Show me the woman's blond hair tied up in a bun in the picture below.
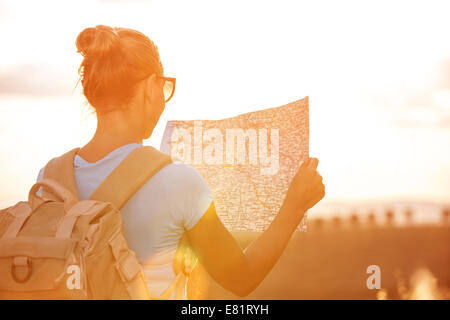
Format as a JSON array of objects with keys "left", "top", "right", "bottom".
[{"left": 76, "top": 25, "right": 164, "bottom": 114}]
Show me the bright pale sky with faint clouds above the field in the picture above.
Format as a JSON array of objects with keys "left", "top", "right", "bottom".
[{"left": 0, "top": 0, "right": 450, "bottom": 207}]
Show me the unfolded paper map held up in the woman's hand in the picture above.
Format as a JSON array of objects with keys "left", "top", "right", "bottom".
[{"left": 161, "top": 97, "right": 309, "bottom": 231}]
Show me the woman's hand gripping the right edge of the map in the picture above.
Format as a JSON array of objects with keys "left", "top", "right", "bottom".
[{"left": 283, "top": 158, "right": 325, "bottom": 222}]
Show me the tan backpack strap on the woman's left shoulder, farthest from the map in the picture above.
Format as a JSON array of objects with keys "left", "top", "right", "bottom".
[{"left": 42, "top": 148, "right": 80, "bottom": 201}]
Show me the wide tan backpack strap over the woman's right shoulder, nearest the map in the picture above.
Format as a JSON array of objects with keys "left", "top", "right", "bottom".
[{"left": 89, "top": 146, "right": 172, "bottom": 210}]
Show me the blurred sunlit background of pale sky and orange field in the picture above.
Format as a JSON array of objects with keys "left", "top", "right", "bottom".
[{"left": 0, "top": 0, "right": 450, "bottom": 299}]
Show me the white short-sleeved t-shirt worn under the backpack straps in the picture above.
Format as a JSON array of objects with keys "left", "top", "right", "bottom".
[{"left": 37, "top": 143, "right": 213, "bottom": 299}]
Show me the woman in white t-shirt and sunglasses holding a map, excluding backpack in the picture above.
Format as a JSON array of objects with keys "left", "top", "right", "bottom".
[{"left": 38, "top": 25, "right": 325, "bottom": 298}]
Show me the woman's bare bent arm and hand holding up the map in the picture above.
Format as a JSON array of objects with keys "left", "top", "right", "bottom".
[{"left": 187, "top": 158, "right": 325, "bottom": 296}]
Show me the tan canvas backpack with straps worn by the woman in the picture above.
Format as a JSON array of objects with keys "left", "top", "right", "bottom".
[{"left": 0, "top": 146, "right": 207, "bottom": 299}]
